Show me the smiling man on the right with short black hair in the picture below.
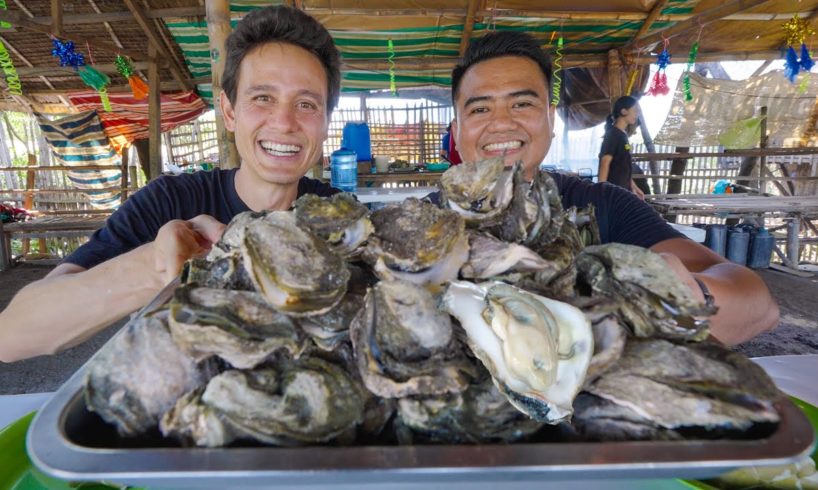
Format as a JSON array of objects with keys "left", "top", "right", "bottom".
[{"left": 452, "top": 31, "right": 778, "bottom": 344}]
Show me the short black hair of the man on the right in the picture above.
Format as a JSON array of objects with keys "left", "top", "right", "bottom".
[{"left": 452, "top": 31, "right": 553, "bottom": 106}]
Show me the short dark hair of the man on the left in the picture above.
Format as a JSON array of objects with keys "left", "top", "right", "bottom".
[{"left": 222, "top": 5, "right": 341, "bottom": 113}]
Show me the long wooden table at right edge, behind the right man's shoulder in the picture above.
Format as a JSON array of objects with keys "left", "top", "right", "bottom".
[{"left": 645, "top": 194, "right": 818, "bottom": 268}]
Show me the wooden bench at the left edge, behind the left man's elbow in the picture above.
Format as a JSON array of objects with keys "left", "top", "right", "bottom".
[{"left": 0, "top": 214, "right": 108, "bottom": 270}]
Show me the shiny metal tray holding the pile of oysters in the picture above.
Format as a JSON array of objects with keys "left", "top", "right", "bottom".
[{"left": 27, "top": 283, "right": 815, "bottom": 489}]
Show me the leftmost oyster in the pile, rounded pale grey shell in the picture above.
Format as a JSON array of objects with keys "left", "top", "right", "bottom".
[{"left": 84, "top": 311, "right": 210, "bottom": 436}]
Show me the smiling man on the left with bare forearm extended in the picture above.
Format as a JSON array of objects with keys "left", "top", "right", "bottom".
[{"left": 0, "top": 6, "right": 341, "bottom": 362}]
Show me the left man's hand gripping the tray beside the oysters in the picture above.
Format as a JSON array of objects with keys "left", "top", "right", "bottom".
[{"left": 153, "top": 214, "right": 225, "bottom": 282}]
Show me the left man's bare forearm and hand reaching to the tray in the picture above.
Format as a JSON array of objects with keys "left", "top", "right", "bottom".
[{"left": 0, "top": 216, "right": 224, "bottom": 362}]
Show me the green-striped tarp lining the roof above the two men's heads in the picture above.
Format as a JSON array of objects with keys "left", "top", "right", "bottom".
[{"left": 164, "top": 0, "right": 699, "bottom": 105}]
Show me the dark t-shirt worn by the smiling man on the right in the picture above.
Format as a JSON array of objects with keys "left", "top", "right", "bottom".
[{"left": 425, "top": 172, "right": 684, "bottom": 248}]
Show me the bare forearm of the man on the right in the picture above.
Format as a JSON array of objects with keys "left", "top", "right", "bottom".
[{"left": 650, "top": 238, "right": 779, "bottom": 345}]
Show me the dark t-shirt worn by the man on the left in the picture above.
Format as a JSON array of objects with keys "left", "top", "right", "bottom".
[{"left": 63, "top": 169, "right": 341, "bottom": 269}]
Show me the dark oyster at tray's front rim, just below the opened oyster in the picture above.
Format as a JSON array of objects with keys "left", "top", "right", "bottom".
[{"left": 398, "top": 376, "right": 543, "bottom": 444}]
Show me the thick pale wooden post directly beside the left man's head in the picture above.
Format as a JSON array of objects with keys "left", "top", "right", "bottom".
[{"left": 205, "top": 0, "right": 241, "bottom": 168}]
